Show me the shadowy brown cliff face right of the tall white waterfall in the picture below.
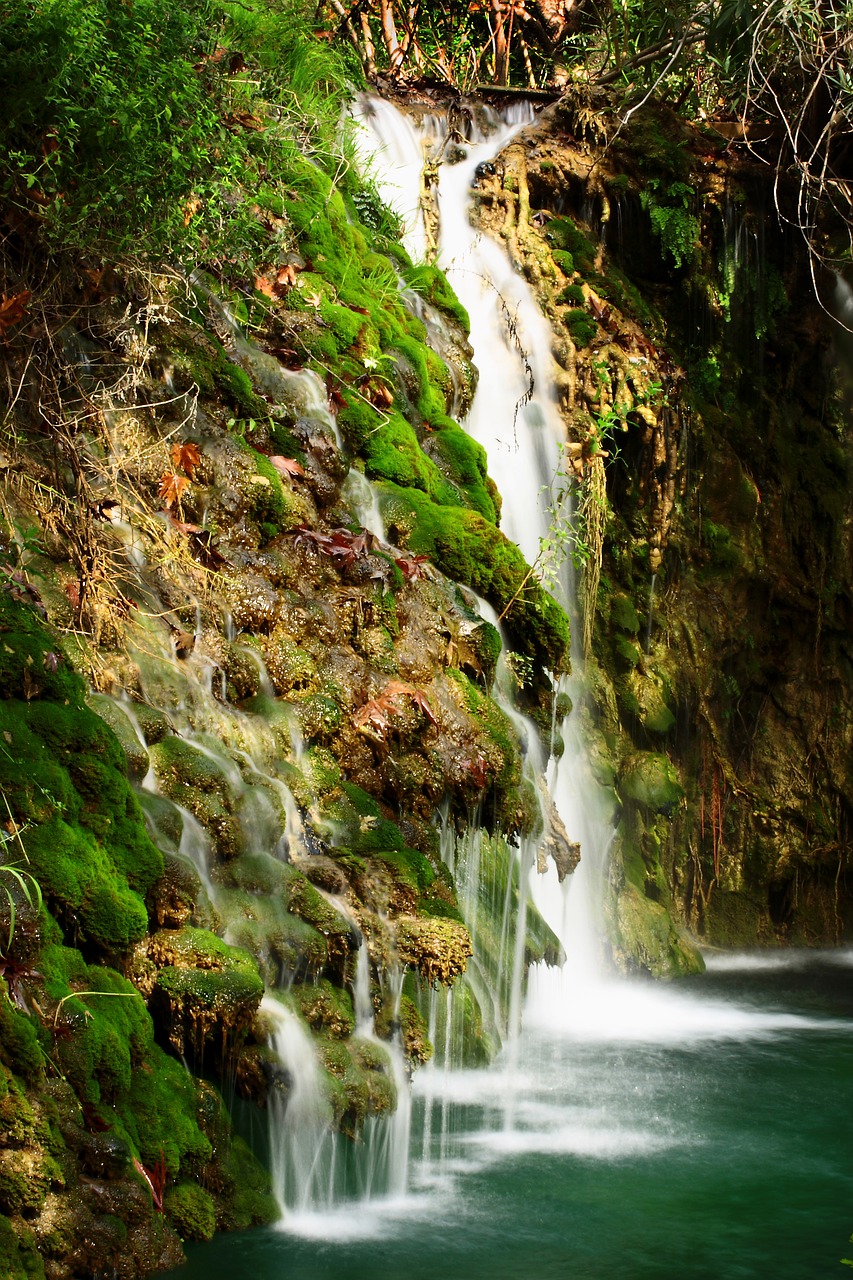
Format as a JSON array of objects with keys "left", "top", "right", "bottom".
[{"left": 468, "top": 93, "right": 853, "bottom": 972}]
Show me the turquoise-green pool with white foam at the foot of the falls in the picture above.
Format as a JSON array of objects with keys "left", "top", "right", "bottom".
[{"left": 172, "top": 952, "right": 853, "bottom": 1280}]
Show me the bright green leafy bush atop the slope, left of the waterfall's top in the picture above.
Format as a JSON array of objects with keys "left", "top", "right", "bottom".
[{"left": 0, "top": 0, "right": 358, "bottom": 269}]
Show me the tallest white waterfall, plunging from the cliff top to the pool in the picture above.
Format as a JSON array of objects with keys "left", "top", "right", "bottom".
[{"left": 359, "top": 100, "right": 612, "bottom": 998}]
